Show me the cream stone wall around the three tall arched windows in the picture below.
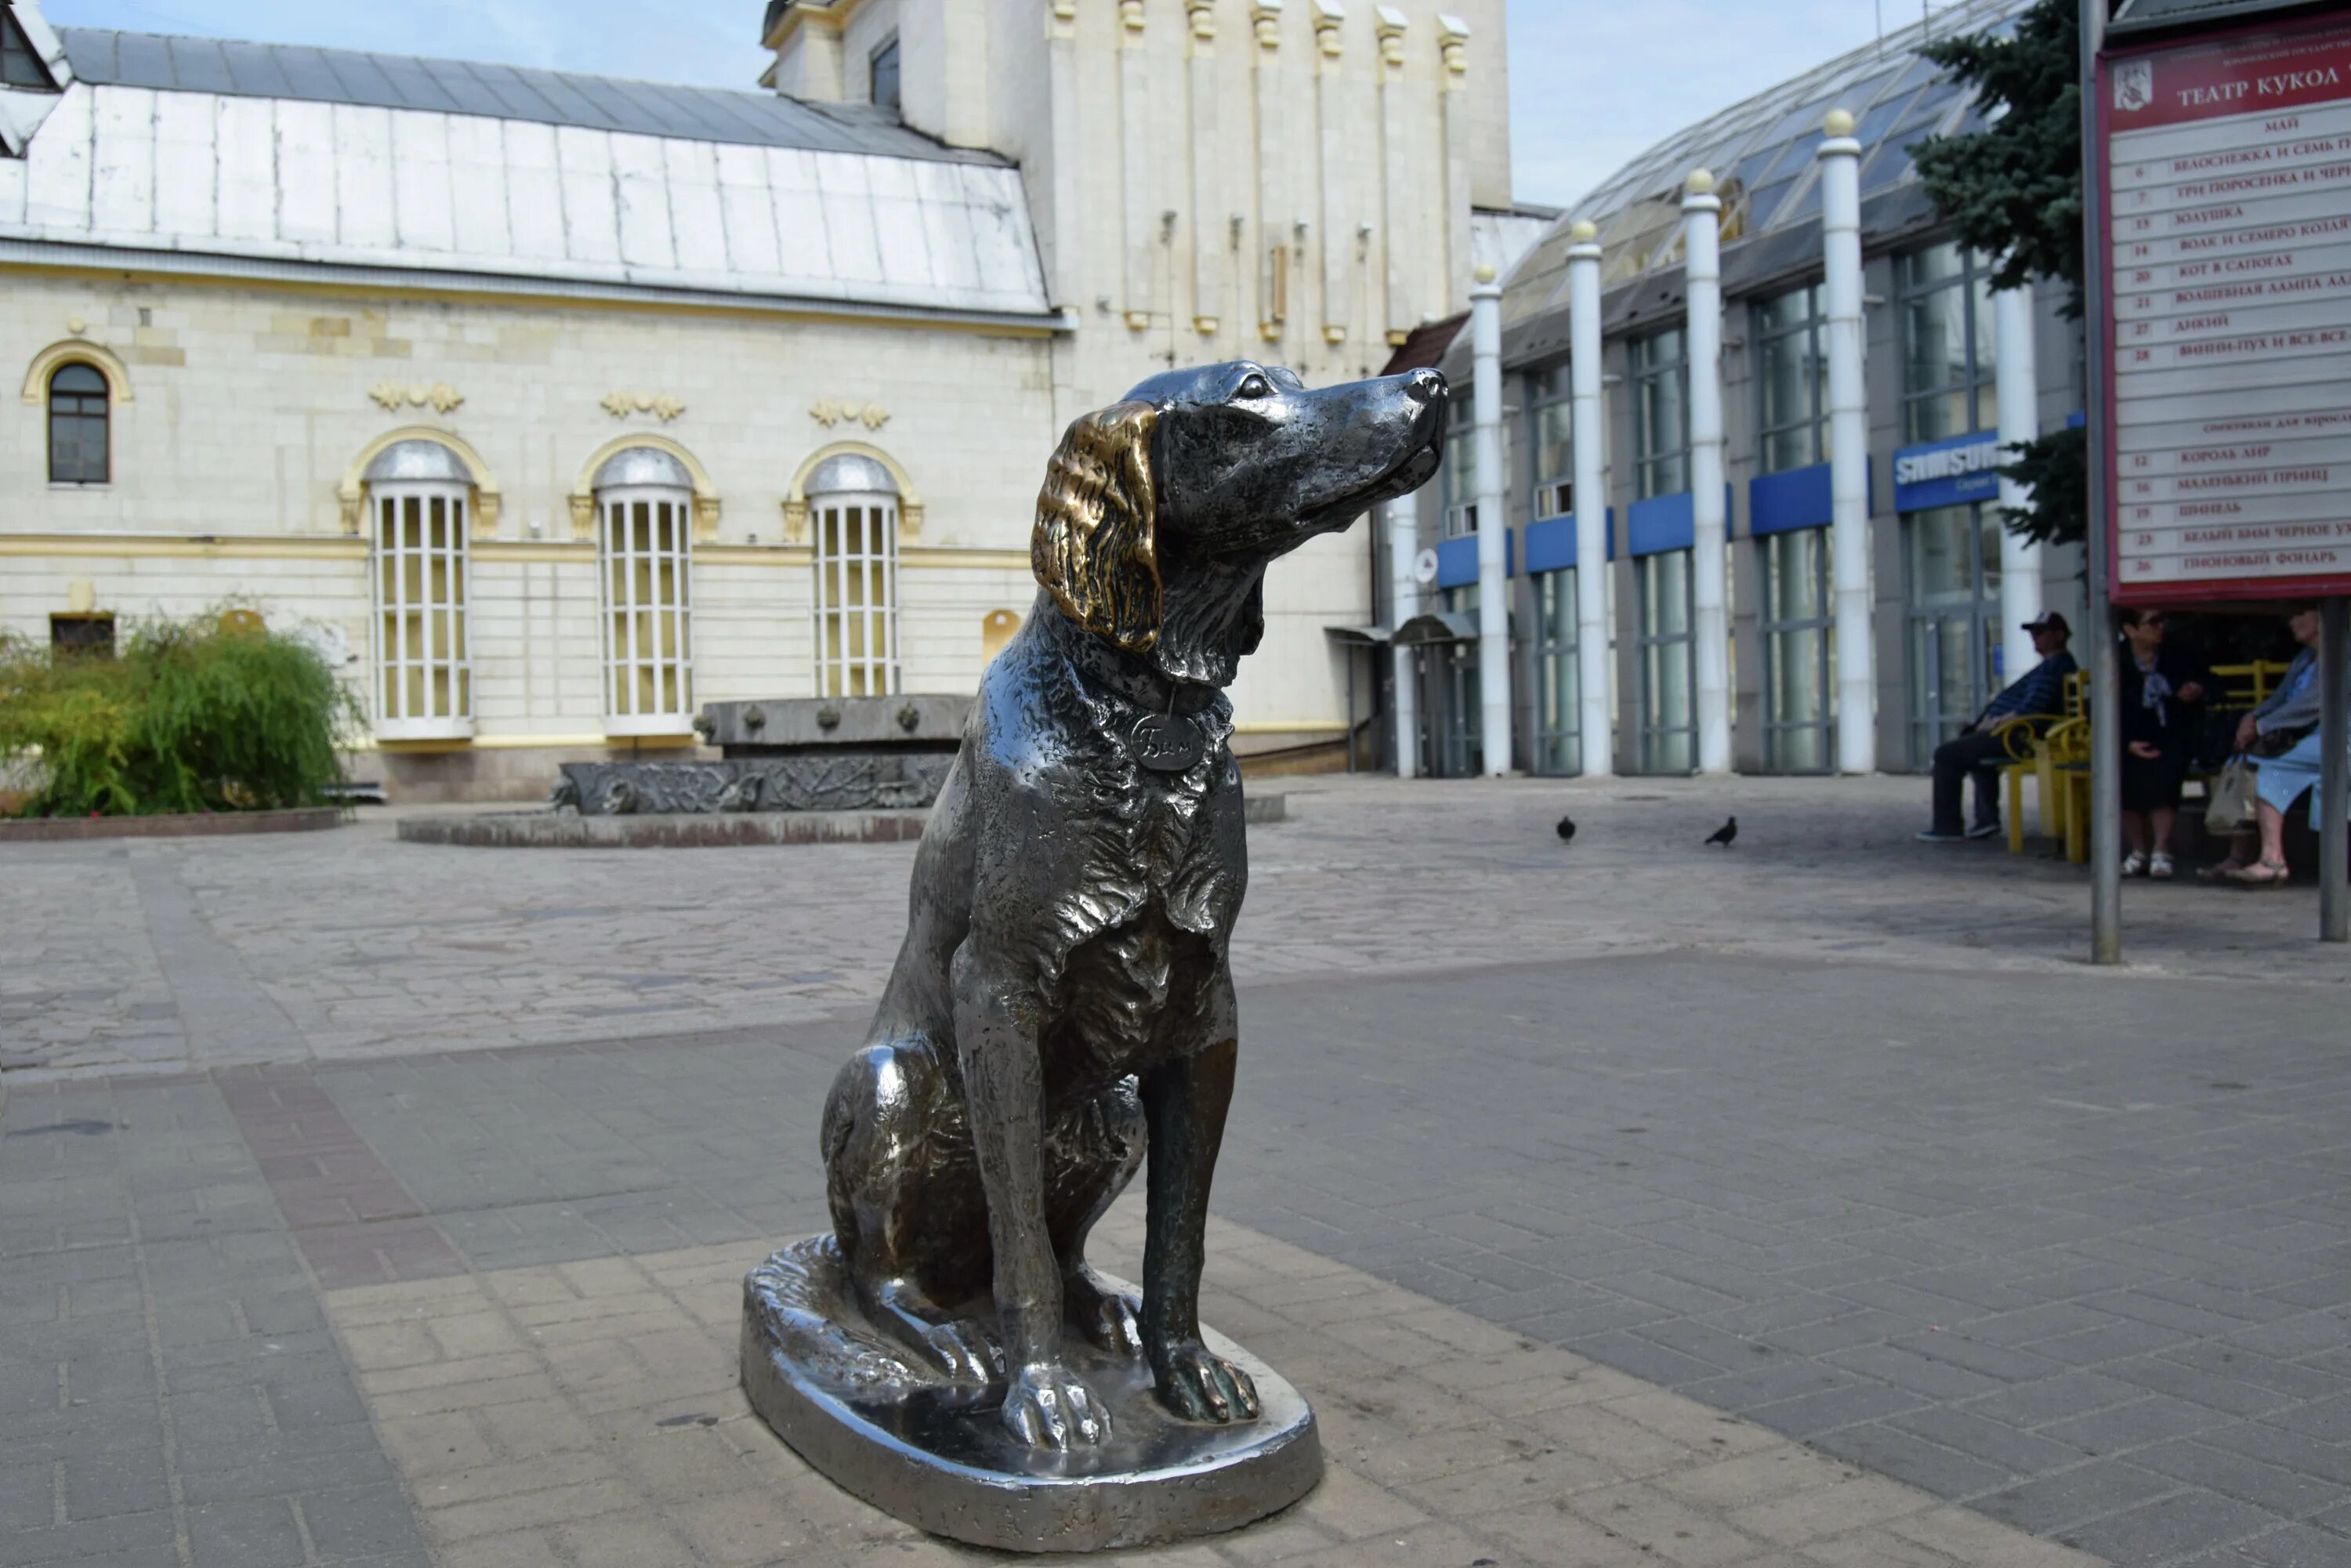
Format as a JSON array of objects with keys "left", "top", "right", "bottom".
[{"left": 0, "top": 273, "right": 1051, "bottom": 790}]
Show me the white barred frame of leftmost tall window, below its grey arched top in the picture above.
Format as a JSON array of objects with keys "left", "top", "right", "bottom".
[{"left": 367, "top": 480, "right": 473, "bottom": 741}]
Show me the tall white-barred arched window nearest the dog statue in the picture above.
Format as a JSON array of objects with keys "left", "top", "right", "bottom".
[{"left": 806, "top": 451, "right": 898, "bottom": 696}]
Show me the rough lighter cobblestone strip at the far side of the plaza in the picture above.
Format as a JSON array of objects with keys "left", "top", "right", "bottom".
[{"left": 0, "top": 778, "right": 2351, "bottom": 1072}]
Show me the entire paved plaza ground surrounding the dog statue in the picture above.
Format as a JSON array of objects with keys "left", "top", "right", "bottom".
[{"left": 0, "top": 780, "right": 2351, "bottom": 1568}]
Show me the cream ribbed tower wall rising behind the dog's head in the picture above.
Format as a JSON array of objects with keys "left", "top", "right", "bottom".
[{"left": 778, "top": 0, "right": 1509, "bottom": 743}]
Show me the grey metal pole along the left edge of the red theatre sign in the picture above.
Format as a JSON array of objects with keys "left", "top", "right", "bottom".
[{"left": 2081, "top": 0, "right": 2123, "bottom": 964}]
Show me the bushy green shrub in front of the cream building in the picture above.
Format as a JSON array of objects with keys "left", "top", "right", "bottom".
[{"left": 0, "top": 611, "right": 360, "bottom": 816}]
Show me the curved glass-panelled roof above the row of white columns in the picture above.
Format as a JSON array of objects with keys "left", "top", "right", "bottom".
[{"left": 1502, "top": 0, "right": 2031, "bottom": 322}]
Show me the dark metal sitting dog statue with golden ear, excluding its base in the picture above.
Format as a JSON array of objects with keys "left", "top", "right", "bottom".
[{"left": 823, "top": 362, "right": 1446, "bottom": 1448}]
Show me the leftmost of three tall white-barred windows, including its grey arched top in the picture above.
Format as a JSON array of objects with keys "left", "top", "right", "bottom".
[{"left": 364, "top": 442, "right": 473, "bottom": 741}]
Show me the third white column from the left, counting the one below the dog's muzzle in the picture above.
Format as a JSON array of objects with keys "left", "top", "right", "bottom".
[{"left": 1568, "top": 223, "right": 1615, "bottom": 778}]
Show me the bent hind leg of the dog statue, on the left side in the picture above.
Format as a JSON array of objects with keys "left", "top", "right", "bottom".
[{"left": 823, "top": 1034, "right": 1004, "bottom": 1382}]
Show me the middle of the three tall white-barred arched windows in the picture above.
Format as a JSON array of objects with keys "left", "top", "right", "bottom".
[{"left": 590, "top": 447, "right": 694, "bottom": 736}]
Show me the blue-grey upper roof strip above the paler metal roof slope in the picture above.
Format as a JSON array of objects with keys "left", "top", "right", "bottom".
[{"left": 56, "top": 28, "right": 1004, "bottom": 165}]
